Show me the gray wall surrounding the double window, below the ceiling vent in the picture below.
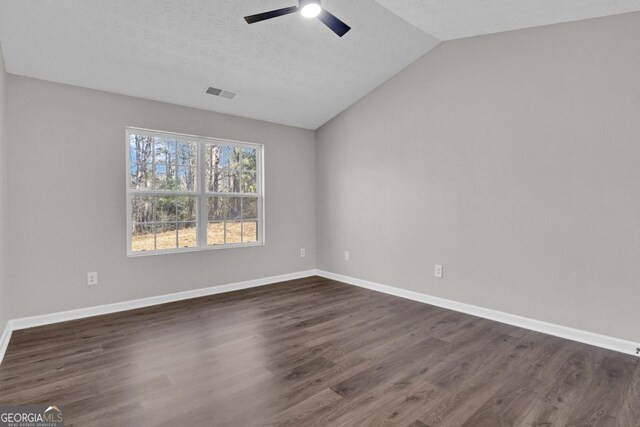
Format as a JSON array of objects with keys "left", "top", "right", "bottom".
[{"left": 3, "top": 75, "right": 316, "bottom": 318}]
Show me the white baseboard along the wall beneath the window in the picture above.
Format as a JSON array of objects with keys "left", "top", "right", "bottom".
[{"left": 7, "top": 270, "right": 316, "bottom": 331}]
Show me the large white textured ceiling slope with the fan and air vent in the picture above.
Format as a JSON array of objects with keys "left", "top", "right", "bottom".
[{"left": 0, "top": 0, "right": 438, "bottom": 129}]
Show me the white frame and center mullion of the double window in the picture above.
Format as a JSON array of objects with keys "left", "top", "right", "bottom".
[{"left": 125, "top": 127, "right": 265, "bottom": 257}]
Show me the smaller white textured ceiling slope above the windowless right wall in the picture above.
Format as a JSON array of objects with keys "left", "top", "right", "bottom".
[{"left": 376, "top": 0, "right": 640, "bottom": 40}]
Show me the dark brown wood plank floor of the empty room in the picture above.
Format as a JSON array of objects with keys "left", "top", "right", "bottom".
[{"left": 0, "top": 277, "right": 640, "bottom": 427}]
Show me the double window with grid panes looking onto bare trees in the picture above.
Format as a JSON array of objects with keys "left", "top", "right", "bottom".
[{"left": 126, "top": 128, "right": 264, "bottom": 255}]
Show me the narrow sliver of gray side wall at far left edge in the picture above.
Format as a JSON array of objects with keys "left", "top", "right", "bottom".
[{"left": 0, "top": 48, "right": 9, "bottom": 336}]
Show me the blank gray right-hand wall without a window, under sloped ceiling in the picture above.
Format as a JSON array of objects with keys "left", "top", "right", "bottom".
[{"left": 316, "top": 13, "right": 640, "bottom": 341}]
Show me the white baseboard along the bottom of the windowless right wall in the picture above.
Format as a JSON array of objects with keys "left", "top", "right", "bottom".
[{"left": 316, "top": 270, "right": 640, "bottom": 356}]
